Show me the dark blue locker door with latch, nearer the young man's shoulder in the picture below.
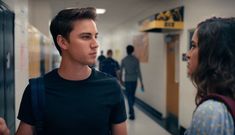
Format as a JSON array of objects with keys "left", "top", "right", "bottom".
[{"left": 3, "top": 6, "right": 15, "bottom": 134}]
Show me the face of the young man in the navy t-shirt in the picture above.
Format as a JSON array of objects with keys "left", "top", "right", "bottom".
[{"left": 63, "top": 19, "right": 98, "bottom": 65}]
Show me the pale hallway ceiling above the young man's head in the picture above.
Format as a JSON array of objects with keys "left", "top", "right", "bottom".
[{"left": 44, "top": 0, "right": 171, "bottom": 33}]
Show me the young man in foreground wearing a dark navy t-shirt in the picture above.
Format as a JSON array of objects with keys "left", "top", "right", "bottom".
[{"left": 0, "top": 8, "right": 127, "bottom": 135}]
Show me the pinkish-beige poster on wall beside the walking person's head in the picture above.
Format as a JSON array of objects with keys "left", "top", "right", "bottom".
[{"left": 133, "top": 33, "right": 149, "bottom": 63}]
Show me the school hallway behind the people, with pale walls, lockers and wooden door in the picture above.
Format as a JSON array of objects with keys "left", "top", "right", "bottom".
[{"left": 0, "top": 0, "right": 235, "bottom": 135}]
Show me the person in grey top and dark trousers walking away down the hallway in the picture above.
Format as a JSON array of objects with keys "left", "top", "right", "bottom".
[{"left": 120, "top": 45, "right": 144, "bottom": 120}]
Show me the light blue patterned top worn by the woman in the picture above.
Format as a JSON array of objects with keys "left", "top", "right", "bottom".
[{"left": 184, "top": 100, "right": 235, "bottom": 135}]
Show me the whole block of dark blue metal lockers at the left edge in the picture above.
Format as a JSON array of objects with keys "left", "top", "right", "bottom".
[{"left": 0, "top": 1, "right": 15, "bottom": 135}]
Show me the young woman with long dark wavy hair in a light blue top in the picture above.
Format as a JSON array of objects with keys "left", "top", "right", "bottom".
[{"left": 185, "top": 17, "right": 235, "bottom": 135}]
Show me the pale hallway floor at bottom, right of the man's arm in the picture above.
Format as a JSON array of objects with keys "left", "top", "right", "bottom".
[{"left": 127, "top": 107, "right": 170, "bottom": 135}]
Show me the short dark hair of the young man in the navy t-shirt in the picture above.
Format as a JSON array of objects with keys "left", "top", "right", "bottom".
[{"left": 50, "top": 7, "right": 96, "bottom": 55}]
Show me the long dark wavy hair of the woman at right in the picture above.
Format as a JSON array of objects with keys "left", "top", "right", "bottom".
[{"left": 191, "top": 17, "right": 235, "bottom": 105}]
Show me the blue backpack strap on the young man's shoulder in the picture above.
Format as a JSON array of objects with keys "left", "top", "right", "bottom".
[{"left": 29, "top": 77, "right": 45, "bottom": 135}]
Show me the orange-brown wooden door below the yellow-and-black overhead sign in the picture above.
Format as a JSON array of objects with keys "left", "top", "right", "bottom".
[{"left": 165, "top": 34, "right": 179, "bottom": 133}]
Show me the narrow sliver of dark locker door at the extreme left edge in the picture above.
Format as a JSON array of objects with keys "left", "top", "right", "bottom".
[{"left": 0, "top": 6, "right": 5, "bottom": 117}]
